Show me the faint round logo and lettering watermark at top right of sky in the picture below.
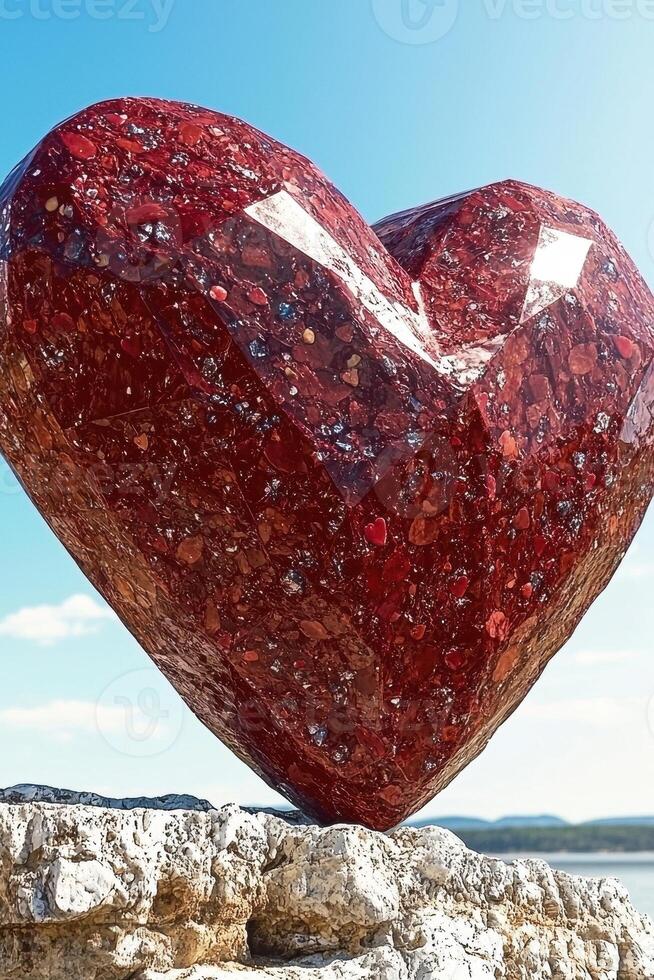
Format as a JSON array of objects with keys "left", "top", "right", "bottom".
[{"left": 372, "top": 0, "right": 654, "bottom": 44}]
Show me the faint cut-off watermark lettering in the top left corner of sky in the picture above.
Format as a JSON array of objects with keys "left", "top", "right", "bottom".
[{"left": 0, "top": 0, "right": 175, "bottom": 34}]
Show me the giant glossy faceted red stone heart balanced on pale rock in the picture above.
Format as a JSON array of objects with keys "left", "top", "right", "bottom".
[{"left": 0, "top": 99, "right": 654, "bottom": 829}]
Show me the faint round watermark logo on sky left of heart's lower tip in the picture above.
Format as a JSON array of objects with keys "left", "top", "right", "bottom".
[{"left": 95, "top": 667, "right": 184, "bottom": 759}]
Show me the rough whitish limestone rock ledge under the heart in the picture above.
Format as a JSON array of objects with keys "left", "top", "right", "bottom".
[{"left": 0, "top": 787, "right": 654, "bottom": 980}]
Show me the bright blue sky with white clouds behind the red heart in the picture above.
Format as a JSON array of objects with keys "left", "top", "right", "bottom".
[{"left": 0, "top": 0, "right": 654, "bottom": 819}]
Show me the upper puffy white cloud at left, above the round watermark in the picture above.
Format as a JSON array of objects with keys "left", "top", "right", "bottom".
[{"left": 0, "top": 595, "right": 114, "bottom": 646}]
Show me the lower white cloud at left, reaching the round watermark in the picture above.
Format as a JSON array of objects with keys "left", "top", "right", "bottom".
[{"left": 0, "top": 700, "right": 125, "bottom": 742}]
